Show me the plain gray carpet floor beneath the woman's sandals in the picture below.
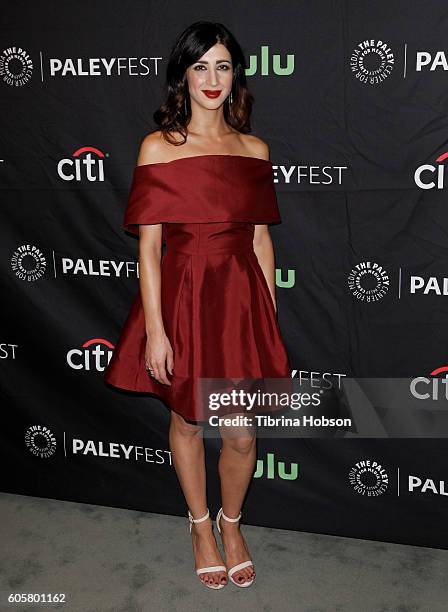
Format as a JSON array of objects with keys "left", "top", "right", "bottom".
[{"left": 0, "top": 493, "right": 448, "bottom": 612}]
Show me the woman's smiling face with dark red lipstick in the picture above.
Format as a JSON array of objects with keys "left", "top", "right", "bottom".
[{"left": 187, "top": 43, "right": 233, "bottom": 109}]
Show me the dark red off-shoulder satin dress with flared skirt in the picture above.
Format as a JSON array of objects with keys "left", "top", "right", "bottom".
[{"left": 104, "top": 154, "right": 291, "bottom": 422}]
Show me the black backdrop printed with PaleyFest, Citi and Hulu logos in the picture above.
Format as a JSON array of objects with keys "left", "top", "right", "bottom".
[{"left": 0, "top": 0, "right": 448, "bottom": 548}]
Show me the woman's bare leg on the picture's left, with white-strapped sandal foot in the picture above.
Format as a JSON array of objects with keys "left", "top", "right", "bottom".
[{"left": 169, "top": 410, "right": 227, "bottom": 584}]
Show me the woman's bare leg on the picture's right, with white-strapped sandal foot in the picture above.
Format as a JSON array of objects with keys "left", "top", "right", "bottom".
[{"left": 218, "top": 414, "right": 257, "bottom": 582}]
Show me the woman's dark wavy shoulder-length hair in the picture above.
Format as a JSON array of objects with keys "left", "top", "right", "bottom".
[{"left": 153, "top": 21, "right": 254, "bottom": 145}]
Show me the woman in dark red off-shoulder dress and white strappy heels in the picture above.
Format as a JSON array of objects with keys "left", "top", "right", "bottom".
[{"left": 105, "top": 21, "right": 291, "bottom": 588}]
